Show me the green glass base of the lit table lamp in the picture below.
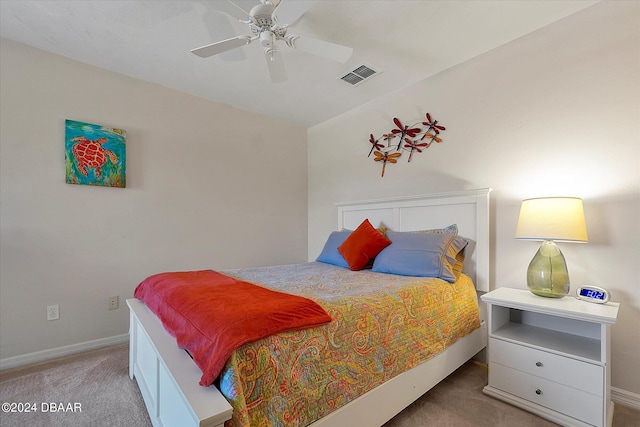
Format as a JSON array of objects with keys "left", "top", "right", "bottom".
[{"left": 527, "top": 240, "right": 570, "bottom": 298}]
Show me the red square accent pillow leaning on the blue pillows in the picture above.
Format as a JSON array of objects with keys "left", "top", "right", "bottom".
[{"left": 338, "top": 219, "right": 391, "bottom": 271}]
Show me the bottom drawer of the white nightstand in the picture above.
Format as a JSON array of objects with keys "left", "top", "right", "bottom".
[{"left": 489, "top": 363, "right": 603, "bottom": 425}]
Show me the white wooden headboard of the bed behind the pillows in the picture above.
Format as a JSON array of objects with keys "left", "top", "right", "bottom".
[{"left": 336, "top": 188, "right": 491, "bottom": 292}]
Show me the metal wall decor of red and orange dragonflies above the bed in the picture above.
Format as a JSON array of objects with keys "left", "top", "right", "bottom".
[{"left": 368, "top": 113, "right": 445, "bottom": 177}]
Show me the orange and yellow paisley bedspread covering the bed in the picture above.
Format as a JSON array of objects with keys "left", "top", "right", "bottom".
[{"left": 219, "top": 262, "right": 480, "bottom": 427}]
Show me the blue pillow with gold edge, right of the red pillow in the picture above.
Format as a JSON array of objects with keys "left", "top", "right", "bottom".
[{"left": 372, "top": 231, "right": 468, "bottom": 283}]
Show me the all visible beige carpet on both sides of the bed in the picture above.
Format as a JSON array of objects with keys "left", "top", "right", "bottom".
[{"left": 0, "top": 345, "right": 640, "bottom": 427}]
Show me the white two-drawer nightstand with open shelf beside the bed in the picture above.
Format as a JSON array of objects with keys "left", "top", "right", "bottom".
[{"left": 481, "top": 288, "right": 619, "bottom": 427}]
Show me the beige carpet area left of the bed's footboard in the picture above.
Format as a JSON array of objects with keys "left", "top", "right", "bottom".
[{"left": 0, "top": 344, "right": 151, "bottom": 427}]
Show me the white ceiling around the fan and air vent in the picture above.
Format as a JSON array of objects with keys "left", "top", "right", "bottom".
[{"left": 0, "top": 0, "right": 596, "bottom": 127}]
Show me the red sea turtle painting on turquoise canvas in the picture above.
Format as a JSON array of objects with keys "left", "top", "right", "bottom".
[{"left": 65, "top": 120, "right": 126, "bottom": 187}]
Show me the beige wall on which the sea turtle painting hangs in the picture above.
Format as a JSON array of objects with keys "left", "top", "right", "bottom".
[{"left": 0, "top": 40, "right": 307, "bottom": 359}]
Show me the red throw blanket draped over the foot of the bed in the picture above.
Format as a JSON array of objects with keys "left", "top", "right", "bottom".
[{"left": 134, "top": 270, "right": 331, "bottom": 386}]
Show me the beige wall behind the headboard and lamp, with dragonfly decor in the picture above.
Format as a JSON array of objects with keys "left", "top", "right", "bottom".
[{"left": 308, "top": 2, "right": 640, "bottom": 395}]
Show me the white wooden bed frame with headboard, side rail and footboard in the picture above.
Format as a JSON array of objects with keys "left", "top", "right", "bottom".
[{"left": 127, "top": 188, "right": 491, "bottom": 427}]
